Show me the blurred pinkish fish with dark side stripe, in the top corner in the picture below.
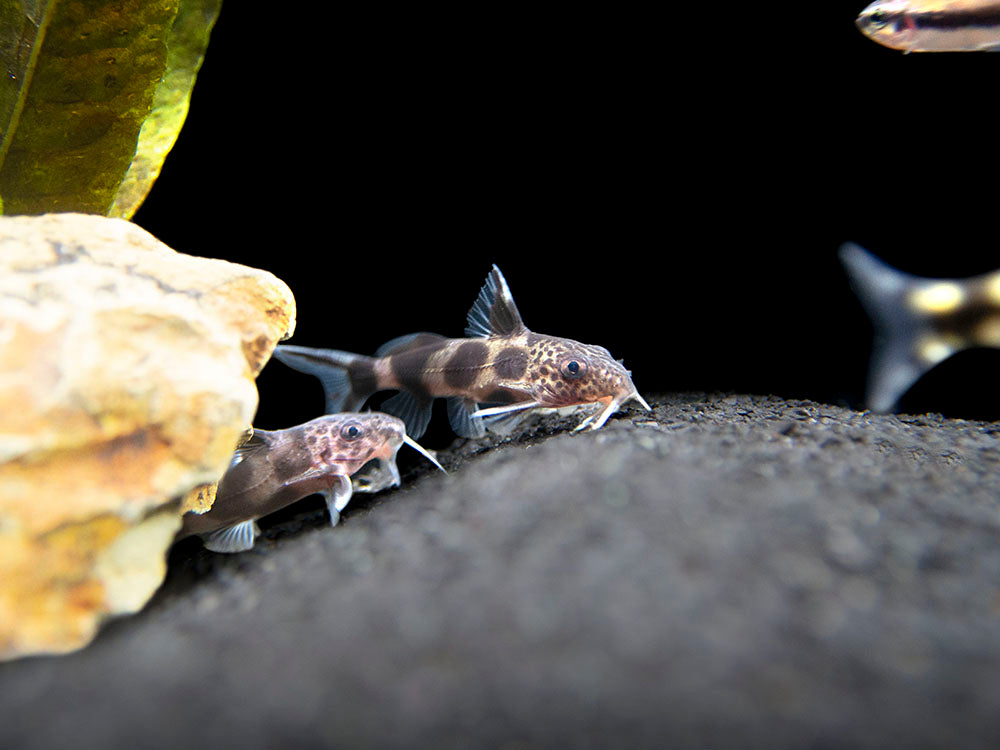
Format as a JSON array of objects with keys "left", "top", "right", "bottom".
[{"left": 855, "top": 0, "right": 1000, "bottom": 52}]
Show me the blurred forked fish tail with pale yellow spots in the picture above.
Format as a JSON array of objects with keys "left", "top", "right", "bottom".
[{"left": 840, "top": 243, "right": 1000, "bottom": 411}]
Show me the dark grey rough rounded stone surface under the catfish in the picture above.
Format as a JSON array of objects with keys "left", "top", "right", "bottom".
[{"left": 0, "top": 394, "right": 1000, "bottom": 748}]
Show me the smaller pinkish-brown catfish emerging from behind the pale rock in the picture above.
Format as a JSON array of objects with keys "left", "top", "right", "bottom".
[{"left": 178, "top": 412, "right": 444, "bottom": 552}]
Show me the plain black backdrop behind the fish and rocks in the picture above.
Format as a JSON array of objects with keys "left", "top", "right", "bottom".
[{"left": 135, "top": 2, "right": 1000, "bottom": 443}]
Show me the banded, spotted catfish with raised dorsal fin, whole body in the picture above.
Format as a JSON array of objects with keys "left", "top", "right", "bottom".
[{"left": 275, "top": 266, "right": 649, "bottom": 437}]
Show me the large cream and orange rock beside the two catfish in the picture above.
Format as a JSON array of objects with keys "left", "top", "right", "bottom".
[{"left": 0, "top": 214, "right": 295, "bottom": 658}]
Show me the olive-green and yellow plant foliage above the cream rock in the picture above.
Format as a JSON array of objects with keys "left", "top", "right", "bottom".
[{"left": 0, "top": 0, "right": 221, "bottom": 218}]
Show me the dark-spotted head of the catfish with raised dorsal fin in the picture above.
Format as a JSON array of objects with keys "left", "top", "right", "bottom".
[{"left": 526, "top": 336, "right": 649, "bottom": 429}]
